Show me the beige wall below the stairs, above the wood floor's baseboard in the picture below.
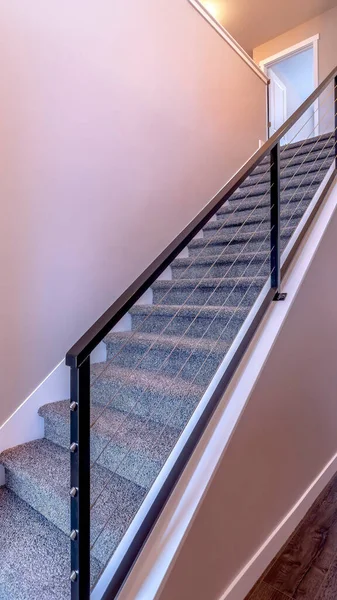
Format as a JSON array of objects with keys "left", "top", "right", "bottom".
[{"left": 159, "top": 185, "right": 337, "bottom": 600}]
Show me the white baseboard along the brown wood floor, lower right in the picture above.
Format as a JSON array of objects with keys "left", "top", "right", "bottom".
[{"left": 219, "top": 454, "right": 337, "bottom": 600}]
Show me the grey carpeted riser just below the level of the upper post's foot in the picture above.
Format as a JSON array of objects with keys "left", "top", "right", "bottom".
[{"left": 132, "top": 313, "right": 244, "bottom": 343}]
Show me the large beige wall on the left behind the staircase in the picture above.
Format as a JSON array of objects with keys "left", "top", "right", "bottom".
[{"left": 0, "top": 0, "right": 265, "bottom": 423}]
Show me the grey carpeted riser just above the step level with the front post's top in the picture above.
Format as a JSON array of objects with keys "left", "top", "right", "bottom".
[{"left": 104, "top": 342, "right": 225, "bottom": 386}]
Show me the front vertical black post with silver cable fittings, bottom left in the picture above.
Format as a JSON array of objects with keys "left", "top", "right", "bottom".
[{"left": 70, "top": 356, "right": 90, "bottom": 600}]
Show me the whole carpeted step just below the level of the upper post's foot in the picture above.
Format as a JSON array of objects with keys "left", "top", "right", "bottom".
[{"left": 130, "top": 304, "right": 248, "bottom": 342}]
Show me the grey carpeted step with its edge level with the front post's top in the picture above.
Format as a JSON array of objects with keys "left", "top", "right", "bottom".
[{"left": 91, "top": 358, "right": 205, "bottom": 429}]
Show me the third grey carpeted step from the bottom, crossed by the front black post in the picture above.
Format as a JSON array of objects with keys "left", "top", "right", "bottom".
[{"left": 39, "top": 397, "right": 180, "bottom": 488}]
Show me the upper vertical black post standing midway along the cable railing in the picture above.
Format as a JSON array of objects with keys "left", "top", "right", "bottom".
[{"left": 270, "top": 142, "right": 281, "bottom": 300}]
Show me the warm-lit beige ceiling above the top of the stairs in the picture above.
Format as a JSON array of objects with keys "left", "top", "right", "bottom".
[{"left": 201, "top": 0, "right": 337, "bottom": 54}]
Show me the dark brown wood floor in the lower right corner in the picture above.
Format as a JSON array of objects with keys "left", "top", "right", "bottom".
[{"left": 246, "top": 475, "right": 337, "bottom": 600}]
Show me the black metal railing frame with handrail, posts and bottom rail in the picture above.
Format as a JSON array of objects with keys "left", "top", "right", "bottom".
[{"left": 66, "top": 67, "right": 337, "bottom": 600}]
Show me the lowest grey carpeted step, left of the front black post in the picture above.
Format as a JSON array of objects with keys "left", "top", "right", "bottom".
[{"left": 0, "top": 487, "right": 101, "bottom": 600}]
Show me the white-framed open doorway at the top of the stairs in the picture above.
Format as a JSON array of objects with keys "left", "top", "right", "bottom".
[{"left": 260, "top": 36, "right": 319, "bottom": 145}]
